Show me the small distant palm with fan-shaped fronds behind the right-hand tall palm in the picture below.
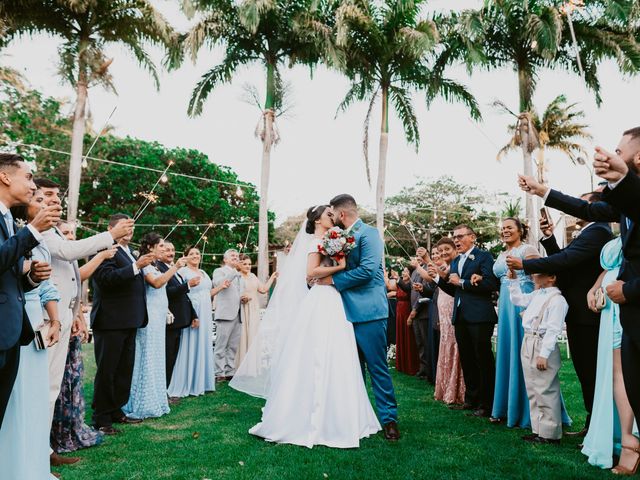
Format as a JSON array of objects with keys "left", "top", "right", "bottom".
[{"left": 494, "top": 95, "right": 593, "bottom": 183}]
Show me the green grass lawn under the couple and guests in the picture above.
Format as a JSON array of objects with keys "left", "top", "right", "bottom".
[{"left": 53, "top": 346, "right": 611, "bottom": 480}]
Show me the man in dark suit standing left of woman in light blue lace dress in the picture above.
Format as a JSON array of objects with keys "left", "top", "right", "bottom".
[{"left": 91, "top": 214, "right": 154, "bottom": 435}]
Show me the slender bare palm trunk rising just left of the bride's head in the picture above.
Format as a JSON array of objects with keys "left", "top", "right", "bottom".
[{"left": 258, "top": 64, "right": 275, "bottom": 282}]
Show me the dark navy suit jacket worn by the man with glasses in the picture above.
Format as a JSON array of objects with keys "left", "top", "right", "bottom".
[{"left": 438, "top": 247, "right": 500, "bottom": 324}]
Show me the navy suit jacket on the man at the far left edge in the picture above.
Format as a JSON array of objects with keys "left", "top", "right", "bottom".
[{"left": 0, "top": 218, "right": 38, "bottom": 350}]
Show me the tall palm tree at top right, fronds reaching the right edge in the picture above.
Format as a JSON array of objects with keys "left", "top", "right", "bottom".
[{"left": 450, "top": 0, "right": 640, "bottom": 228}]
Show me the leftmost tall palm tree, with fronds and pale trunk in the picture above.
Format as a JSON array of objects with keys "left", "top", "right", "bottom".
[{"left": 3, "top": 0, "right": 173, "bottom": 220}]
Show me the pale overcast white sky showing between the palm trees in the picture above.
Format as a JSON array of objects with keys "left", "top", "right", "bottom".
[{"left": 0, "top": 0, "right": 640, "bottom": 222}]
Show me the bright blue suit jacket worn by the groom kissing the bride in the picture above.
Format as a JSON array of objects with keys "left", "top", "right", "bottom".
[{"left": 333, "top": 220, "right": 389, "bottom": 323}]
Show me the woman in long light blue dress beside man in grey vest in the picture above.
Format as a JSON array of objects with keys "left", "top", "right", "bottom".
[{"left": 169, "top": 247, "right": 216, "bottom": 397}]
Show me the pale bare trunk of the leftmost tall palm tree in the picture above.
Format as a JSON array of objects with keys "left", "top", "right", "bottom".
[{"left": 67, "top": 64, "right": 88, "bottom": 220}]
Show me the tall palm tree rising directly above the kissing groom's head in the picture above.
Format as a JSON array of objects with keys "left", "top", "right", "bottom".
[{"left": 336, "top": 0, "right": 481, "bottom": 235}]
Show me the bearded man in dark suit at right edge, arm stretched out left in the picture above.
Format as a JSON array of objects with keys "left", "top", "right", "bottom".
[{"left": 519, "top": 127, "right": 640, "bottom": 430}]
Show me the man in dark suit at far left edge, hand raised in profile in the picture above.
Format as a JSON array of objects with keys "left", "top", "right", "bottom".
[{"left": 0, "top": 153, "right": 61, "bottom": 427}]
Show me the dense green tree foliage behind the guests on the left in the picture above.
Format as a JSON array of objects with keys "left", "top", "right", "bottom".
[{"left": 0, "top": 77, "right": 274, "bottom": 265}]
